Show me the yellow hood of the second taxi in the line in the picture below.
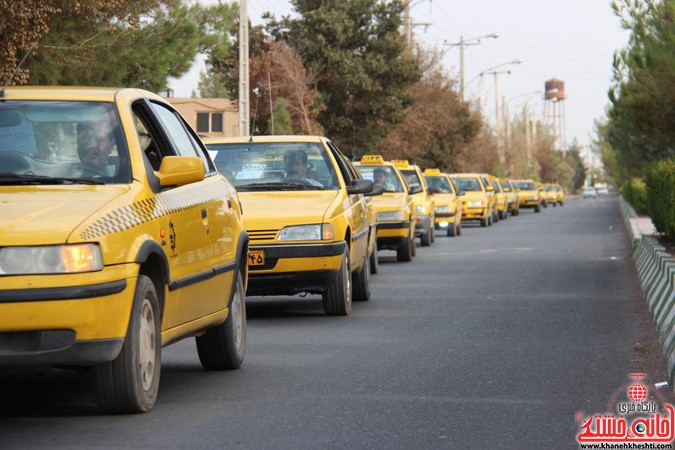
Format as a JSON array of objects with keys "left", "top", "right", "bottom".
[{"left": 238, "top": 191, "right": 339, "bottom": 230}]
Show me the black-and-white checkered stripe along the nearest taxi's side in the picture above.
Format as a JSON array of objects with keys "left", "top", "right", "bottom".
[{"left": 80, "top": 179, "right": 229, "bottom": 240}]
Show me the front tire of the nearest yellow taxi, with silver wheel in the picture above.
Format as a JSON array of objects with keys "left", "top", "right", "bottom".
[{"left": 91, "top": 275, "right": 162, "bottom": 413}]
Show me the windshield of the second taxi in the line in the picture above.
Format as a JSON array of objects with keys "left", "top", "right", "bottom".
[{"left": 206, "top": 142, "right": 340, "bottom": 191}]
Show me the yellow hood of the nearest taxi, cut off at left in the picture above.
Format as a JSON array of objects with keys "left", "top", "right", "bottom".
[{"left": 0, "top": 185, "right": 129, "bottom": 246}]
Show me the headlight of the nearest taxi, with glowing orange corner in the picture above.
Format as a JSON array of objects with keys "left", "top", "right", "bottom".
[{"left": 0, "top": 244, "right": 103, "bottom": 275}]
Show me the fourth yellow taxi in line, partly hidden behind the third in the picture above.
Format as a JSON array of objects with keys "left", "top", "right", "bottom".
[{"left": 391, "top": 159, "right": 436, "bottom": 247}]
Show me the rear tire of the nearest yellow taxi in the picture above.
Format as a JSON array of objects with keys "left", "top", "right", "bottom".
[{"left": 195, "top": 272, "right": 246, "bottom": 370}]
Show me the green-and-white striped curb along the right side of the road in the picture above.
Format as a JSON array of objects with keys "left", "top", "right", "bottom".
[{"left": 620, "top": 197, "right": 675, "bottom": 392}]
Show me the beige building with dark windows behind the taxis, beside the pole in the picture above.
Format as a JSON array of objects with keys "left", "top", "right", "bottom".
[{"left": 166, "top": 97, "right": 239, "bottom": 137}]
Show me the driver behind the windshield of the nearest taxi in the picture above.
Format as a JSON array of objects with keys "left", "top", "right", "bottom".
[{"left": 77, "top": 122, "right": 115, "bottom": 175}]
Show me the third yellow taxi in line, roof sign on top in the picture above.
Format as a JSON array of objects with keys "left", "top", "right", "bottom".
[{"left": 354, "top": 155, "right": 422, "bottom": 262}]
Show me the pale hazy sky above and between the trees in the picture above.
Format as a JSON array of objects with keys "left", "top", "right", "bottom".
[{"left": 170, "top": 0, "right": 629, "bottom": 152}]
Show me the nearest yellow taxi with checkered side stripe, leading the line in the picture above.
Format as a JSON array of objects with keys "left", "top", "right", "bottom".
[{"left": 0, "top": 87, "right": 248, "bottom": 412}]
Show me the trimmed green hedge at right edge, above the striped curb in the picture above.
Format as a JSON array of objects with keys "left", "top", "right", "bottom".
[{"left": 644, "top": 158, "right": 675, "bottom": 239}]
